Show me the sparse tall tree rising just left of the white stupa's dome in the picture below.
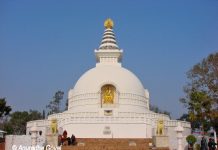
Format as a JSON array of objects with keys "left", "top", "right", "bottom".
[{"left": 46, "top": 91, "right": 64, "bottom": 114}]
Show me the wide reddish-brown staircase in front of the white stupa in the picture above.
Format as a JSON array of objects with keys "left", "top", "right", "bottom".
[{"left": 62, "top": 138, "right": 169, "bottom": 150}]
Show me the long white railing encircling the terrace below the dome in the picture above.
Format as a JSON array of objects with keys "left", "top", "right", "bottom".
[{"left": 27, "top": 112, "right": 190, "bottom": 128}]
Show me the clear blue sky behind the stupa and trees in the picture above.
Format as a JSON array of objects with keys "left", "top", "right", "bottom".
[{"left": 0, "top": 0, "right": 218, "bottom": 118}]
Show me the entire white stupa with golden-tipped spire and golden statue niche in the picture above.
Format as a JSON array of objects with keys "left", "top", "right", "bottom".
[{"left": 27, "top": 19, "right": 190, "bottom": 147}]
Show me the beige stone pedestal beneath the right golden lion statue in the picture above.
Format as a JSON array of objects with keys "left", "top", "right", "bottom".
[{"left": 152, "top": 135, "right": 169, "bottom": 147}]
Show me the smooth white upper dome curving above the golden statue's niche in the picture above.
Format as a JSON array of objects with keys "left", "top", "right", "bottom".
[{"left": 74, "top": 65, "right": 145, "bottom": 96}]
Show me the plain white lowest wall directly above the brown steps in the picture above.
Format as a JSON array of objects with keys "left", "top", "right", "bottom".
[{"left": 63, "top": 123, "right": 147, "bottom": 138}]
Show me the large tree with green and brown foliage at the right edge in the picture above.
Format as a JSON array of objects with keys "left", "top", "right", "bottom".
[{"left": 180, "top": 53, "right": 218, "bottom": 130}]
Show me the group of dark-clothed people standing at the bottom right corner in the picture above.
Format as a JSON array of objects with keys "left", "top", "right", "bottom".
[{"left": 201, "top": 136, "right": 217, "bottom": 150}]
